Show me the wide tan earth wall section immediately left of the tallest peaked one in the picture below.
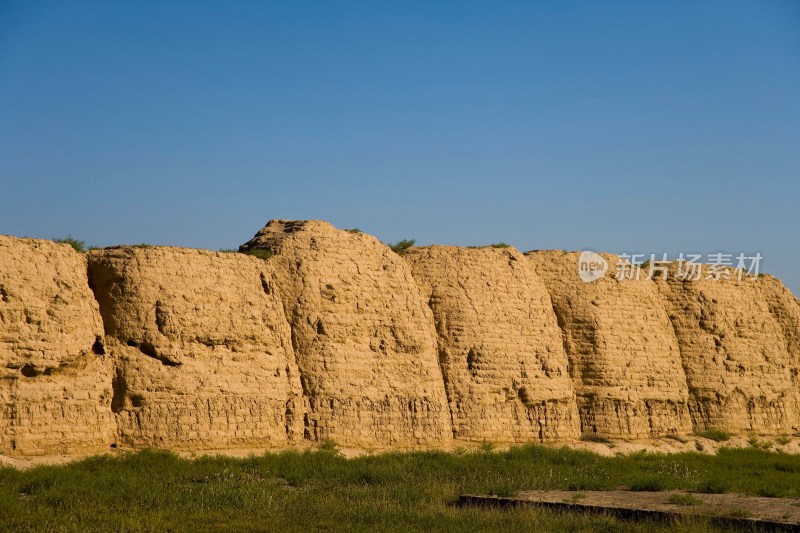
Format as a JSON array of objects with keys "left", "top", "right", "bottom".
[{"left": 89, "top": 247, "right": 302, "bottom": 448}]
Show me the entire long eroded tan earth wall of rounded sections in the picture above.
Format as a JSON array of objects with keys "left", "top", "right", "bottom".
[{"left": 0, "top": 220, "right": 800, "bottom": 455}]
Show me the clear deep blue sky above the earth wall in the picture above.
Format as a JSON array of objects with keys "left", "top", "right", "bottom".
[{"left": 0, "top": 0, "right": 800, "bottom": 294}]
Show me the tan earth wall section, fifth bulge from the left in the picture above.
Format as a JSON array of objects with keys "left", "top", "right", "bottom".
[{"left": 526, "top": 251, "right": 691, "bottom": 437}]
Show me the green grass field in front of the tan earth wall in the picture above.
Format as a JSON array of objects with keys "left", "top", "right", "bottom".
[{"left": 0, "top": 446, "right": 800, "bottom": 532}]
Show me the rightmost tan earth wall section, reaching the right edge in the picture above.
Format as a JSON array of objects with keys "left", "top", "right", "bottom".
[{"left": 655, "top": 265, "right": 800, "bottom": 434}]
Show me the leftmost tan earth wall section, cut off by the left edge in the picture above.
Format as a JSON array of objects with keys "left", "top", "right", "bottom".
[{"left": 0, "top": 236, "right": 116, "bottom": 455}]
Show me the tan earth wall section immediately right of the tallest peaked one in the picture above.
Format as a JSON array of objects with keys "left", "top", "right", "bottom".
[{"left": 403, "top": 246, "right": 580, "bottom": 442}]
